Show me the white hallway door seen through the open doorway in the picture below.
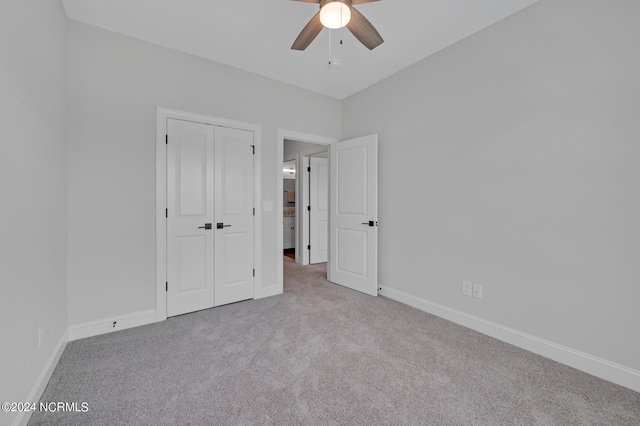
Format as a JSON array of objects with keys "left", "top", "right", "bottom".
[{"left": 309, "top": 157, "right": 329, "bottom": 263}]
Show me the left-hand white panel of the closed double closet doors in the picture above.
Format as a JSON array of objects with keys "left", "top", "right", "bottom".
[{"left": 167, "top": 119, "right": 214, "bottom": 316}]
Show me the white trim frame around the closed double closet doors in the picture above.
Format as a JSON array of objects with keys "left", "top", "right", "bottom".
[{"left": 155, "top": 107, "right": 262, "bottom": 321}]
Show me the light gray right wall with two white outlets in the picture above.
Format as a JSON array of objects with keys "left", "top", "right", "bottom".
[{"left": 342, "top": 0, "right": 640, "bottom": 370}]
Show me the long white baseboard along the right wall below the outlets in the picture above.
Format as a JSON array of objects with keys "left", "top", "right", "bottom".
[{"left": 379, "top": 287, "right": 640, "bottom": 392}]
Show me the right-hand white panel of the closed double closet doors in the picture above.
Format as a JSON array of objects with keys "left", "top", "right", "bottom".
[{"left": 214, "top": 127, "right": 254, "bottom": 306}]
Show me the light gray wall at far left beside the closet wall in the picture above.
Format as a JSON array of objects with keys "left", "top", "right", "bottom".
[{"left": 0, "top": 0, "right": 67, "bottom": 424}]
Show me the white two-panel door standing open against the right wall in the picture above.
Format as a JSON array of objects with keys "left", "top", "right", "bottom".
[{"left": 327, "top": 135, "right": 378, "bottom": 296}]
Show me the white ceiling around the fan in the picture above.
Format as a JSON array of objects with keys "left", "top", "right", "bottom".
[{"left": 62, "top": 0, "right": 537, "bottom": 99}]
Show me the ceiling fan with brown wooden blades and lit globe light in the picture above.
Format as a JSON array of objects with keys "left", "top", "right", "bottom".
[{"left": 291, "top": 0, "right": 384, "bottom": 50}]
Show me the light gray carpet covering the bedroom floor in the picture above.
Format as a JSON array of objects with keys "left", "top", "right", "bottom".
[{"left": 29, "top": 258, "right": 640, "bottom": 425}]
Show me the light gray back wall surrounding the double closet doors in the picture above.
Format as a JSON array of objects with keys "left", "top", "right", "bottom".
[{"left": 69, "top": 21, "right": 340, "bottom": 325}]
